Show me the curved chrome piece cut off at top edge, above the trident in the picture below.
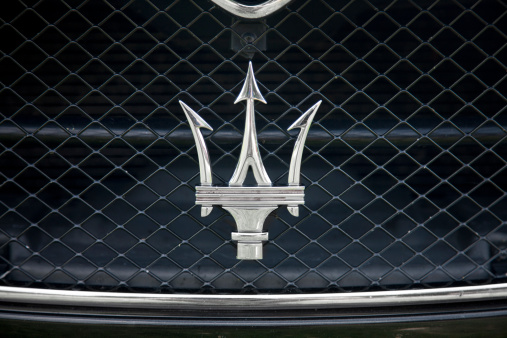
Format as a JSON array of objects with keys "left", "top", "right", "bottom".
[{"left": 211, "top": 0, "right": 292, "bottom": 19}]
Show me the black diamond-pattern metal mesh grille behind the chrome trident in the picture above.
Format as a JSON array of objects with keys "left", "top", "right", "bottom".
[{"left": 0, "top": 0, "right": 507, "bottom": 292}]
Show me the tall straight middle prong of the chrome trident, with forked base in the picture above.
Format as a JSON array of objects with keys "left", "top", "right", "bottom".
[{"left": 229, "top": 61, "right": 271, "bottom": 187}]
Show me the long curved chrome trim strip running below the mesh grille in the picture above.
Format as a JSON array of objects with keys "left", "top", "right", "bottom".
[{"left": 0, "top": 283, "right": 507, "bottom": 311}]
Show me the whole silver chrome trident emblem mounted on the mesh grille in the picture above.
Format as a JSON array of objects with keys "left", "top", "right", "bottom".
[{"left": 180, "top": 62, "right": 322, "bottom": 260}]
